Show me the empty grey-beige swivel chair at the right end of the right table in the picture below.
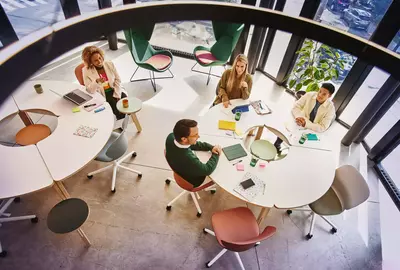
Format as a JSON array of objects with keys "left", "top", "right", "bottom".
[{"left": 287, "top": 165, "right": 369, "bottom": 240}]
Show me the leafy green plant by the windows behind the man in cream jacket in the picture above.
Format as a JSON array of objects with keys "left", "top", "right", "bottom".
[{"left": 289, "top": 39, "right": 346, "bottom": 98}]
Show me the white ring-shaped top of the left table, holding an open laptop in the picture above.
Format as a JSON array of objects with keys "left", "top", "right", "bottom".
[{"left": 0, "top": 81, "right": 114, "bottom": 198}]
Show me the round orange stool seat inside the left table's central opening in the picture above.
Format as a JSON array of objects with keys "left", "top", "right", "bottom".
[{"left": 15, "top": 124, "right": 51, "bottom": 145}]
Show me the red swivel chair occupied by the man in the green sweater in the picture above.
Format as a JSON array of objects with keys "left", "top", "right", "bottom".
[{"left": 164, "top": 150, "right": 215, "bottom": 217}]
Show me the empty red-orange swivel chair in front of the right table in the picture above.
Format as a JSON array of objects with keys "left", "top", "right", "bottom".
[{"left": 203, "top": 207, "right": 276, "bottom": 270}]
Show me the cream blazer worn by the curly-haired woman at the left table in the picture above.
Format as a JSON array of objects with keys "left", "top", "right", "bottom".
[{"left": 82, "top": 61, "right": 127, "bottom": 98}]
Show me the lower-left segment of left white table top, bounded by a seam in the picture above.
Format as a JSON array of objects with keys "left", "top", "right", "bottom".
[{"left": 0, "top": 145, "right": 53, "bottom": 199}]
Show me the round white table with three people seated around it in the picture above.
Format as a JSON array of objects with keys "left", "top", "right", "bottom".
[{"left": 197, "top": 100, "right": 336, "bottom": 223}]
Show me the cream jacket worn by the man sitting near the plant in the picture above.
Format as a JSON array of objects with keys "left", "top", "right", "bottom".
[{"left": 292, "top": 92, "right": 336, "bottom": 132}]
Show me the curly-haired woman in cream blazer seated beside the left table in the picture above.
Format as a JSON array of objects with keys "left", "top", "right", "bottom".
[{"left": 82, "top": 46, "right": 127, "bottom": 119}]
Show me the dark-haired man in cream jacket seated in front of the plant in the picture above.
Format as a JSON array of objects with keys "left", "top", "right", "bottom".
[{"left": 292, "top": 83, "right": 335, "bottom": 132}]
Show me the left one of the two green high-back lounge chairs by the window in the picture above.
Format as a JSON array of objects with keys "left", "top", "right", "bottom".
[{"left": 124, "top": 24, "right": 174, "bottom": 92}]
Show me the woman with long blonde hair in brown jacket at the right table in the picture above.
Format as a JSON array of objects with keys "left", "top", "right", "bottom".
[{"left": 214, "top": 54, "right": 253, "bottom": 108}]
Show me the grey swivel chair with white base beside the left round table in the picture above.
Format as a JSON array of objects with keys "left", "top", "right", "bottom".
[{"left": 87, "top": 115, "right": 142, "bottom": 192}]
